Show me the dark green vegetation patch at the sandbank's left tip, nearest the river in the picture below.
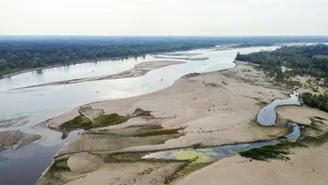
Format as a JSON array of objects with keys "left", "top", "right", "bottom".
[{"left": 60, "top": 115, "right": 92, "bottom": 130}]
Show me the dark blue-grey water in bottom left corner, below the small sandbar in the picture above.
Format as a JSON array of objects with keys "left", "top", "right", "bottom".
[{"left": 0, "top": 128, "right": 78, "bottom": 185}]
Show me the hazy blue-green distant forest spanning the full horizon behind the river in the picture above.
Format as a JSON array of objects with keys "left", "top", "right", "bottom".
[{"left": 0, "top": 36, "right": 328, "bottom": 77}]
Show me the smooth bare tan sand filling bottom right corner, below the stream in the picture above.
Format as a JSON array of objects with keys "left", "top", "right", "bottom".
[{"left": 174, "top": 144, "right": 328, "bottom": 185}]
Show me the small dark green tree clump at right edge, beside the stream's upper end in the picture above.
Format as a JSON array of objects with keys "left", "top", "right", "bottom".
[{"left": 302, "top": 93, "right": 328, "bottom": 112}]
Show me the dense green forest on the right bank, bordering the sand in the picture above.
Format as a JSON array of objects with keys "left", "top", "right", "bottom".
[{"left": 236, "top": 45, "right": 328, "bottom": 86}]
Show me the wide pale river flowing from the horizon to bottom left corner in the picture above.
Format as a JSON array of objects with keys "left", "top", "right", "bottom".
[{"left": 0, "top": 46, "right": 278, "bottom": 185}]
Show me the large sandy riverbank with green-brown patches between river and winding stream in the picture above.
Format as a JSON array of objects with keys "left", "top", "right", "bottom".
[{"left": 38, "top": 63, "right": 302, "bottom": 184}]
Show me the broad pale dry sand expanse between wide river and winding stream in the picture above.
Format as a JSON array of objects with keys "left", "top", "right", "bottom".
[{"left": 49, "top": 63, "right": 287, "bottom": 151}]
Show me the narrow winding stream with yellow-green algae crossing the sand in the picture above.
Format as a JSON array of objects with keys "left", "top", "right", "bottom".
[{"left": 142, "top": 92, "right": 301, "bottom": 162}]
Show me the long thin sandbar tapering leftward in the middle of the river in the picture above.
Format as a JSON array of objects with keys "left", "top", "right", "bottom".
[{"left": 19, "top": 61, "right": 184, "bottom": 89}]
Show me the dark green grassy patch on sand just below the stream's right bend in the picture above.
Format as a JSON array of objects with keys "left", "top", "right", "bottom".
[{"left": 239, "top": 142, "right": 306, "bottom": 161}]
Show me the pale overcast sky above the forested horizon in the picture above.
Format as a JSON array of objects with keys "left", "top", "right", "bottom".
[{"left": 0, "top": 0, "right": 328, "bottom": 36}]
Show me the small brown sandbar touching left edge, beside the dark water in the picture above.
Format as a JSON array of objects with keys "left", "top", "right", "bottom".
[{"left": 0, "top": 130, "right": 41, "bottom": 152}]
